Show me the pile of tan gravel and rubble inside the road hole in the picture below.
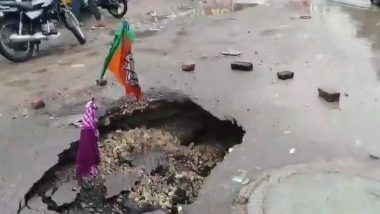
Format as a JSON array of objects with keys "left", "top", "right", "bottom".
[{"left": 100, "top": 128, "right": 229, "bottom": 211}]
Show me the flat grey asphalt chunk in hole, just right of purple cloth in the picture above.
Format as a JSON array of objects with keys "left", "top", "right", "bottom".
[{"left": 104, "top": 171, "right": 140, "bottom": 198}]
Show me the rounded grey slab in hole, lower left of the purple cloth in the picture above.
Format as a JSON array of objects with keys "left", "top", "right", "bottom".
[{"left": 51, "top": 181, "right": 80, "bottom": 207}]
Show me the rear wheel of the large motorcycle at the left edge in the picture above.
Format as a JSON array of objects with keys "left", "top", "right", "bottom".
[{"left": 0, "top": 19, "right": 34, "bottom": 63}]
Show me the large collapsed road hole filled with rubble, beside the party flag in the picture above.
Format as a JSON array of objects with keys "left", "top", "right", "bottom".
[{"left": 19, "top": 100, "right": 245, "bottom": 213}]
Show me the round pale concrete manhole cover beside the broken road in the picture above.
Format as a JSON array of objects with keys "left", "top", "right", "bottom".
[{"left": 238, "top": 160, "right": 380, "bottom": 214}]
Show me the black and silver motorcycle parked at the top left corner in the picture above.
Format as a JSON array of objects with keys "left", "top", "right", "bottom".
[{"left": 0, "top": 0, "right": 86, "bottom": 62}]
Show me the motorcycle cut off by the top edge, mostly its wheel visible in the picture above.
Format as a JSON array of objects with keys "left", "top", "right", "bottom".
[{"left": 62, "top": 0, "right": 128, "bottom": 19}]
